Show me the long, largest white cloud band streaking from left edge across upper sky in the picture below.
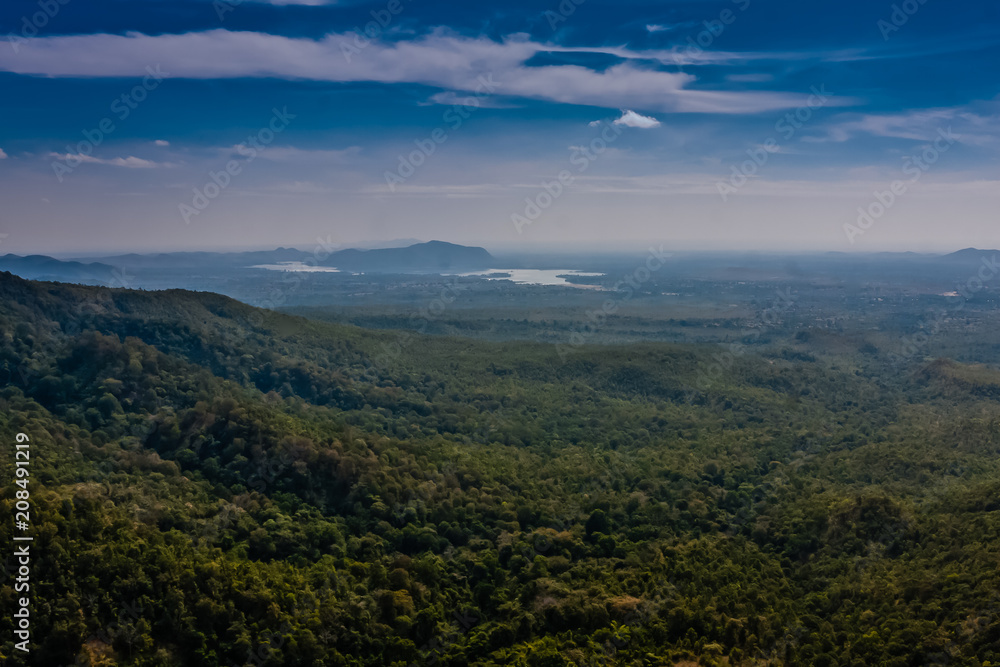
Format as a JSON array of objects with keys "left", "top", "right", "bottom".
[{"left": 0, "top": 29, "right": 843, "bottom": 114}]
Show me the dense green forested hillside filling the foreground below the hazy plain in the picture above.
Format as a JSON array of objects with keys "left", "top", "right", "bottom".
[{"left": 0, "top": 274, "right": 1000, "bottom": 667}]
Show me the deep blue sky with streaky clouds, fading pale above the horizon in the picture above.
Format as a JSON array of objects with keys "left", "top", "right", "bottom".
[{"left": 0, "top": 0, "right": 1000, "bottom": 256}]
